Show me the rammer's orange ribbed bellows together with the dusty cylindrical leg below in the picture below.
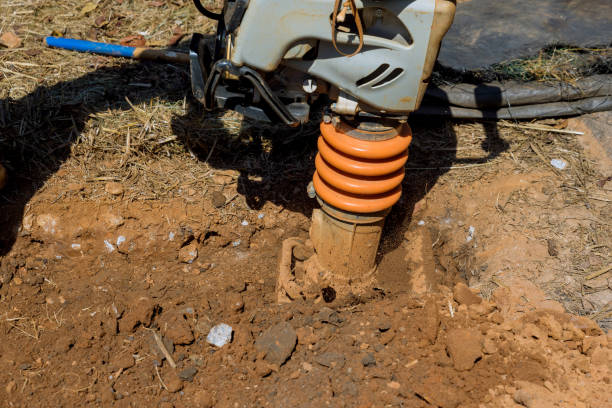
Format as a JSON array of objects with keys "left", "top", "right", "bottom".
[{"left": 310, "top": 123, "right": 412, "bottom": 290}]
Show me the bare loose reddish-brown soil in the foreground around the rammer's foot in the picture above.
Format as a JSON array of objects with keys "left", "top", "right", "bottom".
[{"left": 0, "top": 188, "right": 612, "bottom": 407}]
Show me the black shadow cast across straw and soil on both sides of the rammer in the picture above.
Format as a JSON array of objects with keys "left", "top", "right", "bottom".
[{"left": 0, "top": 58, "right": 507, "bottom": 262}]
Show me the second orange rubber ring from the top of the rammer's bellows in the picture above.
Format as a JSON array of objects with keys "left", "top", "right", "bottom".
[{"left": 317, "top": 137, "right": 408, "bottom": 177}]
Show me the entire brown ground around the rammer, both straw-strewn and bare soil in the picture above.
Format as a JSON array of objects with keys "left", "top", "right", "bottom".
[{"left": 0, "top": 1, "right": 612, "bottom": 407}]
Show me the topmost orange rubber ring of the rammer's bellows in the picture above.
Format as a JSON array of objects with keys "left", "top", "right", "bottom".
[{"left": 321, "top": 123, "right": 412, "bottom": 160}]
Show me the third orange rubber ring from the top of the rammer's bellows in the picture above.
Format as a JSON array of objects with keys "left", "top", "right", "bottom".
[{"left": 315, "top": 153, "right": 404, "bottom": 195}]
